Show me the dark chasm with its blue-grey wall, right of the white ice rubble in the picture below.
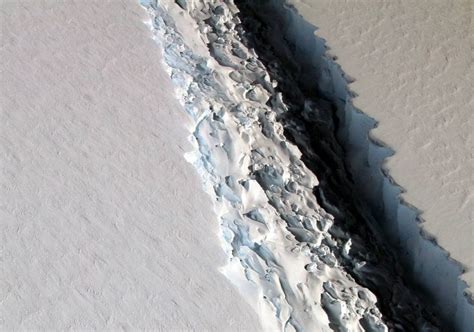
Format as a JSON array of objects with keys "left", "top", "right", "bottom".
[{"left": 229, "top": 0, "right": 474, "bottom": 331}]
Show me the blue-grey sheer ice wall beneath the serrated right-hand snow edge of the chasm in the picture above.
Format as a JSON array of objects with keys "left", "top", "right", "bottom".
[{"left": 236, "top": 0, "right": 474, "bottom": 331}]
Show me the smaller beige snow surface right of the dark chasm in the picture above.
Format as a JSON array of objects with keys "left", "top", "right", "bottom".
[{"left": 290, "top": 0, "right": 474, "bottom": 286}]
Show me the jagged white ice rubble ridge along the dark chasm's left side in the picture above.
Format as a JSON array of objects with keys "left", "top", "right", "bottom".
[{"left": 142, "top": 0, "right": 435, "bottom": 331}]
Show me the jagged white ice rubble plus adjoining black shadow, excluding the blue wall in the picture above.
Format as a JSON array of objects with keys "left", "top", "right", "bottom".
[{"left": 138, "top": 0, "right": 448, "bottom": 331}]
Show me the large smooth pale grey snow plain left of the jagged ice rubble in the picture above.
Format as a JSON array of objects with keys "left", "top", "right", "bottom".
[{"left": 0, "top": 0, "right": 259, "bottom": 331}]
